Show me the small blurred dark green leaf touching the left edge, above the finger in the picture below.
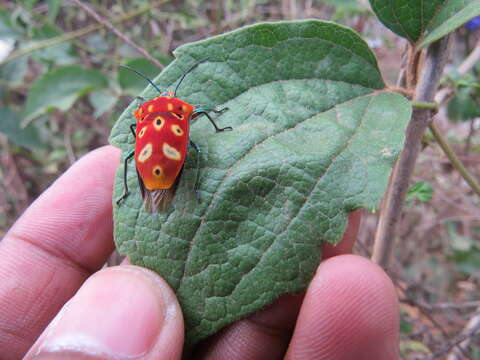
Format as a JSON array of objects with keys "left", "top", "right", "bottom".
[{"left": 0, "top": 108, "right": 43, "bottom": 149}]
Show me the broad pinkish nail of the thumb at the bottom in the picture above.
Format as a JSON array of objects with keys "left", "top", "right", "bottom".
[{"left": 30, "top": 266, "right": 166, "bottom": 359}]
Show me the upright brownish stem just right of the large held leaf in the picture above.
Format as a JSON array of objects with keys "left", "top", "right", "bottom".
[{"left": 372, "top": 36, "right": 449, "bottom": 268}]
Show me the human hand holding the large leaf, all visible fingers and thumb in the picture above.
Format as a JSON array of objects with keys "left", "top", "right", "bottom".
[{"left": 0, "top": 146, "right": 398, "bottom": 360}]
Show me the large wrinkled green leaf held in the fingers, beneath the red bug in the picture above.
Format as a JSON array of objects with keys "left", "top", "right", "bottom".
[{"left": 110, "top": 20, "right": 411, "bottom": 345}]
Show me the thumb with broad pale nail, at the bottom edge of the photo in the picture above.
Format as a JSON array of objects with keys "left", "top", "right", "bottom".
[{"left": 25, "top": 265, "right": 184, "bottom": 360}]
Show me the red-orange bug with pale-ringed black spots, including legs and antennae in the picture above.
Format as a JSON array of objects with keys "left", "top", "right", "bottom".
[{"left": 117, "top": 59, "right": 232, "bottom": 212}]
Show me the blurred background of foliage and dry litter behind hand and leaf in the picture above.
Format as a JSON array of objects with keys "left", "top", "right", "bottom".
[{"left": 0, "top": 0, "right": 480, "bottom": 359}]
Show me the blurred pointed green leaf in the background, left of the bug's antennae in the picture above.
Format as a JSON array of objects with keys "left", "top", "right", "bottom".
[{"left": 23, "top": 65, "right": 108, "bottom": 124}]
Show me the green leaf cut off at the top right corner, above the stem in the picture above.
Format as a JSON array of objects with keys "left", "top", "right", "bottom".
[{"left": 370, "top": 0, "right": 480, "bottom": 47}]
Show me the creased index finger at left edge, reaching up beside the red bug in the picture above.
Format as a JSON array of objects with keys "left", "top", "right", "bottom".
[{"left": 0, "top": 146, "right": 120, "bottom": 358}]
